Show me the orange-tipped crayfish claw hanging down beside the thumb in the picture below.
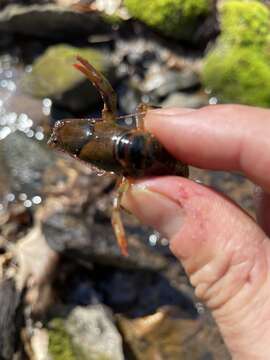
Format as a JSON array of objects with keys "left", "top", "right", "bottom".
[{"left": 112, "top": 177, "right": 129, "bottom": 256}]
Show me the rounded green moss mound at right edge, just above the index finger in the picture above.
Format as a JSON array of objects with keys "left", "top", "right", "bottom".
[{"left": 203, "top": 46, "right": 270, "bottom": 107}]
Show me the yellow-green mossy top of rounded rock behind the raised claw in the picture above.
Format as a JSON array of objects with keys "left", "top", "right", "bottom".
[{"left": 22, "top": 44, "right": 107, "bottom": 98}]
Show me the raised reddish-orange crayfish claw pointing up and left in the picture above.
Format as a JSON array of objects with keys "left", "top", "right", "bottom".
[{"left": 73, "top": 56, "right": 117, "bottom": 119}]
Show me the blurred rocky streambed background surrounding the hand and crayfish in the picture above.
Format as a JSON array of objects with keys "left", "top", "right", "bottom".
[{"left": 0, "top": 0, "right": 270, "bottom": 360}]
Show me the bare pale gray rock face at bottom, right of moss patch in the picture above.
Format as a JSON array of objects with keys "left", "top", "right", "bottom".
[{"left": 66, "top": 305, "right": 124, "bottom": 360}]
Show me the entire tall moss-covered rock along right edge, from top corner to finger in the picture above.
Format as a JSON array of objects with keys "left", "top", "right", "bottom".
[{"left": 202, "top": 0, "right": 270, "bottom": 107}]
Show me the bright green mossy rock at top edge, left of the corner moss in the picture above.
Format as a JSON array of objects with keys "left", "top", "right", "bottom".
[{"left": 124, "top": 0, "right": 213, "bottom": 41}]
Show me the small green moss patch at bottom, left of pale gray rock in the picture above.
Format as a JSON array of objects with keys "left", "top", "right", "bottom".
[{"left": 49, "top": 319, "right": 77, "bottom": 360}]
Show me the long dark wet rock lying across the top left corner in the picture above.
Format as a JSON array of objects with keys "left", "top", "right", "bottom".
[{"left": 0, "top": 4, "right": 111, "bottom": 40}]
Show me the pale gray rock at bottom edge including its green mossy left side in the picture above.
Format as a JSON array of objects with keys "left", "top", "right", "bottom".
[{"left": 49, "top": 305, "right": 124, "bottom": 360}]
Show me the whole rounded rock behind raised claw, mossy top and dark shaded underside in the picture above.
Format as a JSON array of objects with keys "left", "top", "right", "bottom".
[{"left": 23, "top": 45, "right": 112, "bottom": 112}]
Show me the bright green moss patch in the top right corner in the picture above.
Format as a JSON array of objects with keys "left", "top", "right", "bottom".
[{"left": 220, "top": 0, "right": 270, "bottom": 46}]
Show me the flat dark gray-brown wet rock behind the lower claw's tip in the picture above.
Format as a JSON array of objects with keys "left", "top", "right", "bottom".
[{"left": 43, "top": 210, "right": 167, "bottom": 270}]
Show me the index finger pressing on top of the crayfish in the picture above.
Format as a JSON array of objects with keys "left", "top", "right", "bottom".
[{"left": 145, "top": 105, "right": 270, "bottom": 191}]
